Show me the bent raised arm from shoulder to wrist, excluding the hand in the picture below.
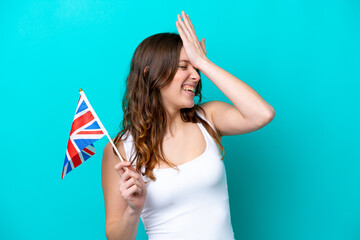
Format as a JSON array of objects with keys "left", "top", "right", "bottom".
[{"left": 199, "top": 60, "right": 275, "bottom": 135}]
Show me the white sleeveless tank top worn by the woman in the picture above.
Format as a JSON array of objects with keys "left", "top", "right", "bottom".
[{"left": 123, "top": 112, "right": 234, "bottom": 240}]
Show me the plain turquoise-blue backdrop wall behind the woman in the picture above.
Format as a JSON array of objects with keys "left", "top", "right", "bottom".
[{"left": 0, "top": 0, "right": 360, "bottom": 240}]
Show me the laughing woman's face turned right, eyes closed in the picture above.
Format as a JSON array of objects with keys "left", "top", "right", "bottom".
[{"left": 160, "top": 47, "right": 200, "bottom": 112}]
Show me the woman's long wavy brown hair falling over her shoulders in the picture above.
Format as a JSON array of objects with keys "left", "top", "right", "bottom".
[{"left": 114, "top": 33, "right": 224, "bottom": 181}]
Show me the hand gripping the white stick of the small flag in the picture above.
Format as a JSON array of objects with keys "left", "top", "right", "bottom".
[{"left": 115, "top": 161, "right": 147, "bottom": 213}]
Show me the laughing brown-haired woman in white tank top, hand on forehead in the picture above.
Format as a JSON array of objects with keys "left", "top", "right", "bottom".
[{"left": 102, "top": 11, "right": 275, "bottom": 240}]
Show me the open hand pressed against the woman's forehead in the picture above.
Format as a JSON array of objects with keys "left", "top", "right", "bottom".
[{"left": 176, "top": 11, "right": 207, "bottom": 68}]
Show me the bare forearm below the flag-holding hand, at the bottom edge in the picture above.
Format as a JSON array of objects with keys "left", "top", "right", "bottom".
[{"left": 105, "top": 207, "right": 141, "bottom": 240}]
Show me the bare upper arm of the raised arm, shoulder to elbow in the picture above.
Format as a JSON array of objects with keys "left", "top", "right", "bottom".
[{"left": 200, "top": 101, "right": 269, "bottom": 136}]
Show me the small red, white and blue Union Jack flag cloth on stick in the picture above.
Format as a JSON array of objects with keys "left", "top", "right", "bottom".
[{"left": 61, "top": 89, "right": 107, "bottom": 179}]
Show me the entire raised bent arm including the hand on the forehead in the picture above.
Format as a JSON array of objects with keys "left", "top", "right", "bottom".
[{"left": 176, "top": 11, "right": 275, "bottom": 135}]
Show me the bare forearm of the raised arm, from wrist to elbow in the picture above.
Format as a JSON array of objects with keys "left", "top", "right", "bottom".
[{"left": 199, "top": 59, "right": 275, "bottom": 121}]
